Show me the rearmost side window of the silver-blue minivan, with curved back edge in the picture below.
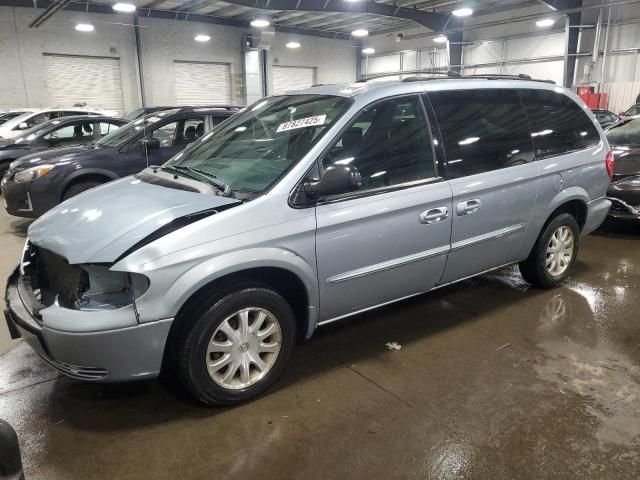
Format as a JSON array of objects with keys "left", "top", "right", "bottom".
[{"left": 520, "top": 90, "right": 600, "bottom": 158}]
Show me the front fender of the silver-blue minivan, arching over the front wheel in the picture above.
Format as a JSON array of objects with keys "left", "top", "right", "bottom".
[{"left": 136, "top": 247, "right": 319, "bottom": 333}]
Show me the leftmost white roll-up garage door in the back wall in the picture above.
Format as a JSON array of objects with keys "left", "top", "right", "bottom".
[{"left": 44, "top": 54, "right": 124, "bottom": 114}]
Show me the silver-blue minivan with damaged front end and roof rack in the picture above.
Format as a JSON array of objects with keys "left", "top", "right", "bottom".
[{"left": 6, "top": 76, "right": 613, "bottom": 405}]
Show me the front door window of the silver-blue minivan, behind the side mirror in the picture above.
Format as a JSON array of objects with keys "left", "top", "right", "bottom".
[{"left": 322, "top": 96, "right": 436, "bottom": 191}]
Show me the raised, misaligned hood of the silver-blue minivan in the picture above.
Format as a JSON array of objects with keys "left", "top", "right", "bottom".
[{"left": 28, "top": 177, "right": 240, "bottom": 264}]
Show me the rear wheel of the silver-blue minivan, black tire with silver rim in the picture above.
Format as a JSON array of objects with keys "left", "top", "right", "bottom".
[{"left": 519, "top": 213, "right": 580, "bottom": 288}]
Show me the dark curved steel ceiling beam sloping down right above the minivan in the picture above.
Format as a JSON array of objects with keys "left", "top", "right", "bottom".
[{"left": 218, "top": 0, "right": 453, "bottom": 31}]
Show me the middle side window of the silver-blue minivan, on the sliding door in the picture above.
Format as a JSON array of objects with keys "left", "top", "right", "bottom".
[{"left": 429, "top": 89, "right": 534, "bottom": 178}]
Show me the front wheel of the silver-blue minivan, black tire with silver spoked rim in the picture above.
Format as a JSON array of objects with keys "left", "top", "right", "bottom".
[{"left": 172, "top": 287, "right": 296, "bottom": 406}]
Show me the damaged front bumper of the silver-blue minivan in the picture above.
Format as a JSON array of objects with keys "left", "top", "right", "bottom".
[{"left": 4, "top": 267, "right": 172, "bottom": 382}]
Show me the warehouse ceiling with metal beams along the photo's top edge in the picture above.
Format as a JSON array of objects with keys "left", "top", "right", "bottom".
[{"left": 12, "top": 0, "right": 544, "bottom": 38}]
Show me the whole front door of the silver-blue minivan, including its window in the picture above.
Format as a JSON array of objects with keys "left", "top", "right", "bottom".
[{"left": 316, "top": 95, "right": 451, "bottom": 321}]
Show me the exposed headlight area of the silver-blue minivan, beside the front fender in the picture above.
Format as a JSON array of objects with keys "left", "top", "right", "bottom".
[{"left": 74, "top": 265, "right": 149, "bottom": 310}]
